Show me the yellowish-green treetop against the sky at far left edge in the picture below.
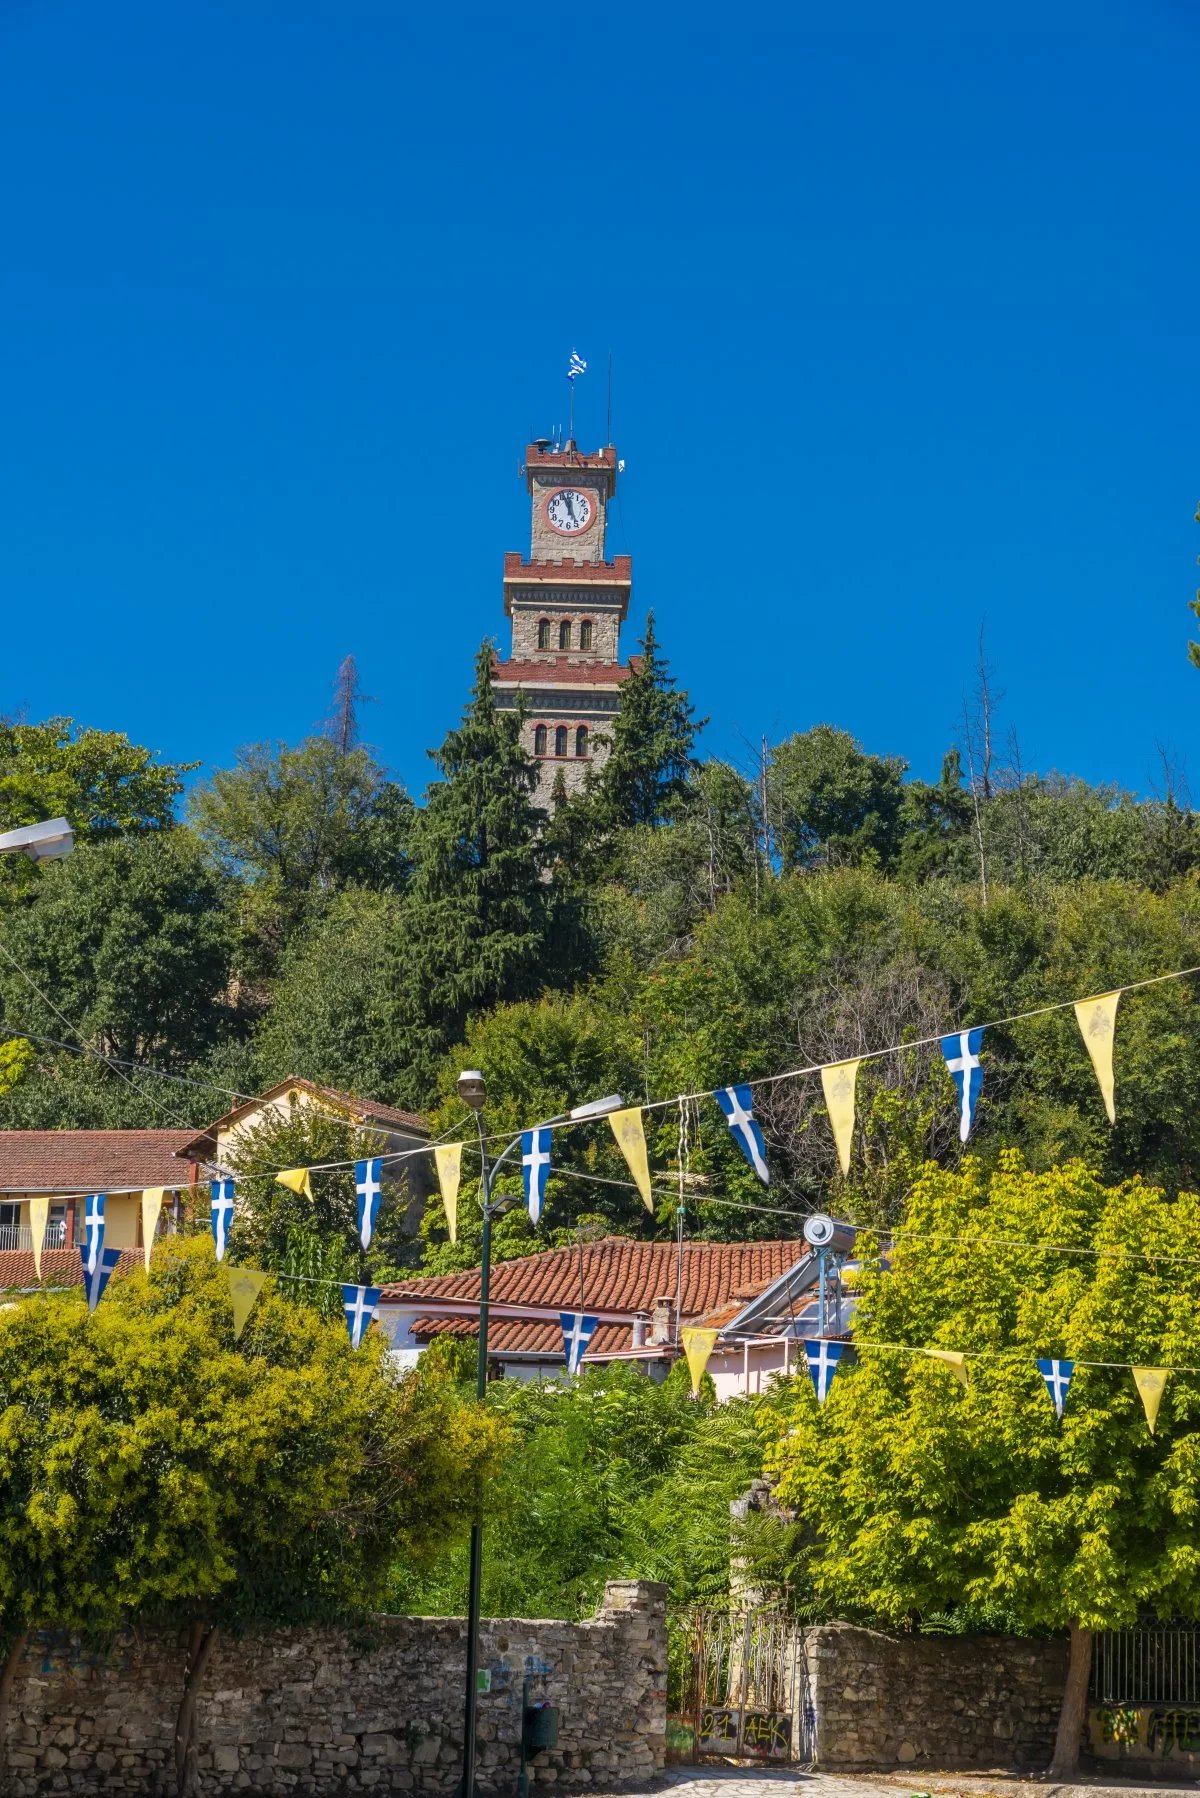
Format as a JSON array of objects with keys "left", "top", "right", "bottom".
[{"left": 0, "top": 717, "right": 200, "bottom": 838}]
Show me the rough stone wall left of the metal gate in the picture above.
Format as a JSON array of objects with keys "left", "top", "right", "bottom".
[{"left": 7, "top": 1580, "right": 667, "bottom": 1798}]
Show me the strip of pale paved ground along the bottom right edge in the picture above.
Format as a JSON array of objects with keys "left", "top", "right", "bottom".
[{"left": 590, "top": 1762, "right": 1196, "bottom": 1798}]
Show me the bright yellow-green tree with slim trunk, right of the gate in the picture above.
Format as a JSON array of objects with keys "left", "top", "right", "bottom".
[{"left": 770, "top": 1153, "right": 1200, "bottom": 1778}]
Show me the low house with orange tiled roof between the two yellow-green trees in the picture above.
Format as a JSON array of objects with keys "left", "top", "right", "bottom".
[{"left": 376, "top": 1237, "right": 831, "bottom": 1397}]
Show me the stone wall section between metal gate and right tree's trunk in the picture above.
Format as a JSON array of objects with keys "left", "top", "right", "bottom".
[{"left": 806, "top": 1624, "right": 1067, "bottom": 1771}]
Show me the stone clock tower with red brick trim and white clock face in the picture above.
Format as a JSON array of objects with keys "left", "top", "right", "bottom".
[{"left": 495, "top": 439, "right": 633, "bottom": 809}]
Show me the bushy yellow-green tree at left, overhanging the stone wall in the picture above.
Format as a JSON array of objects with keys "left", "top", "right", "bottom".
[{"left": 0, "top": 1239, "right": 502, "bottom": 1793}]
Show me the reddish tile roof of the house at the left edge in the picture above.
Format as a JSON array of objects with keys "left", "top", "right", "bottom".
[{"left": 0, "top": 1129, "right": 198, "bottom": 1192}]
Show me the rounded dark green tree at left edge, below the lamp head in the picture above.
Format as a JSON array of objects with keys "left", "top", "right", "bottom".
[{"left": 0, "top": 831, "right": 232, "bottom": 1070}]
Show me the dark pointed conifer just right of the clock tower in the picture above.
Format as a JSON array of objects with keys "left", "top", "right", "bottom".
[{"left": 596, "top": 611, "right": 707, "bottom": 827}]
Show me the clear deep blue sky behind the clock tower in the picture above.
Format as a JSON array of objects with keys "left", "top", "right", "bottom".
[{"left": 0, "top": 0, "right": 1200, "bottom": 793}]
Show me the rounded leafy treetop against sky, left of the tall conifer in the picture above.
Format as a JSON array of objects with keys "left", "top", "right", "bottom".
[{"left": 189, "top": 737, "right": 412, "bottom": 906}]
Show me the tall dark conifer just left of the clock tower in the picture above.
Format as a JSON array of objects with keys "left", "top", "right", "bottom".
[{"left": 405, "top": 642, "right": 549, "bottom": 1055}]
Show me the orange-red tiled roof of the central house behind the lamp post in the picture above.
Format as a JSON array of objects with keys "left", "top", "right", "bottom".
[{"left": 381, "top": 1237, "right": 808, "bottom": 1359}]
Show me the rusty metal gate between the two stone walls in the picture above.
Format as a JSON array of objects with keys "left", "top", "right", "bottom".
[{"left": 667, "top": 1609, "right": 815, "bottom": 1764}]
